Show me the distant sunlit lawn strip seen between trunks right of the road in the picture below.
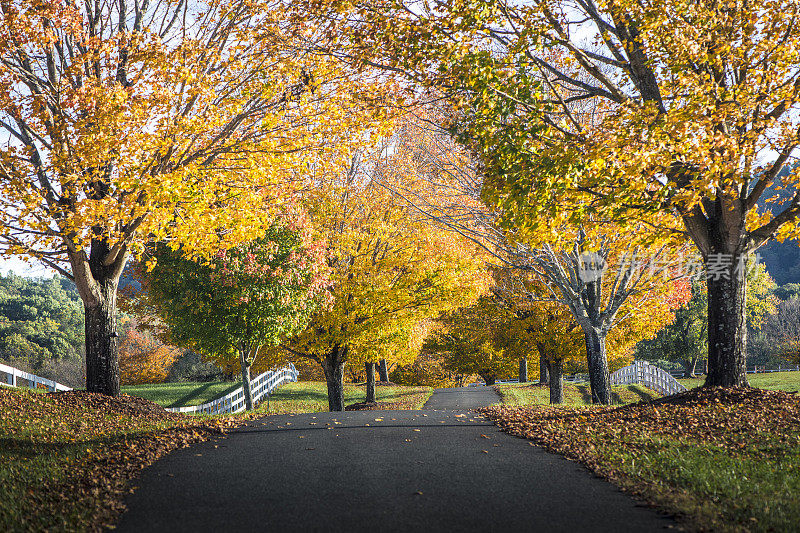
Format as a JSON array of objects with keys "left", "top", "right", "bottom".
[{"left": 495, "top": 383, "right": 658, "bottom": 406}]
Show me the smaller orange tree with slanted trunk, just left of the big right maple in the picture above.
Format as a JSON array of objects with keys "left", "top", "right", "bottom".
[{"left": 484, "top": 227, "right": 689, "bottom": 404}]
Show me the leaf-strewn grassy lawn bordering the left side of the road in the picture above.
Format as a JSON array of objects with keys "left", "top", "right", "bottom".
[{"left": 0, "top": 387, "right": 241, "bottom": 531}]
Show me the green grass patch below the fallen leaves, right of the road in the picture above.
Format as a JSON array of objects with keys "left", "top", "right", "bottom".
[{"left": 598, "top": 435, "right": 800, "bottom": 531}]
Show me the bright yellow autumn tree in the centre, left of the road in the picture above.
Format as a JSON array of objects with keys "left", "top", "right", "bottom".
[{"left": 274, "top": 147, "right": 487, "bottom": 411}]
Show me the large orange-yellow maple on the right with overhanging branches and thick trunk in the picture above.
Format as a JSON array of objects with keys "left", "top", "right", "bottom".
[{"left": 312, "top": 0, "right": 800, "bottom": 386}]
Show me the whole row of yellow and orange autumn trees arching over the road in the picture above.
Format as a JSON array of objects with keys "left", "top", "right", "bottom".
[{"left": 0, "top": 0, "right": 800, "bottom": 409}]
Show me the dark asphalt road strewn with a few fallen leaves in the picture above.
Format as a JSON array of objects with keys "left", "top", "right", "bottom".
[{"left": 118, "top": 387, "right": 673, "bottom": 533}]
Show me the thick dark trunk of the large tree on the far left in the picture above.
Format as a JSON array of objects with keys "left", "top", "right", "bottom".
[{"left": 83, "top": 279, "right": 119, "bottom": 396}]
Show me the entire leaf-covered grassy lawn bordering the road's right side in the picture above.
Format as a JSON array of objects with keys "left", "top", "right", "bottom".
[{"left": 484, "top": 388, "right": 800, "bottom": 532}]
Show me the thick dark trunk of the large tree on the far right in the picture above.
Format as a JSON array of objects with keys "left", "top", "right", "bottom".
[{"left": 705, "top": 270, "right": 748, "bottom": 387}]
